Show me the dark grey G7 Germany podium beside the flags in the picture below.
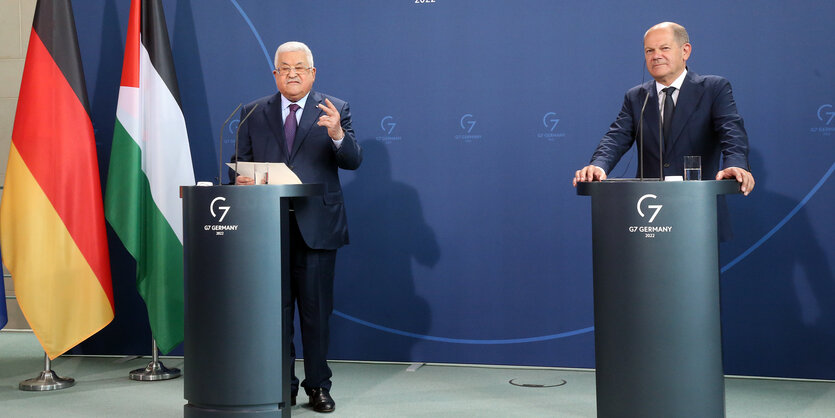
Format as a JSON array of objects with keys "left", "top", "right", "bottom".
[{"left": 182, "top": 184, "right": 324, "bottom": 417}]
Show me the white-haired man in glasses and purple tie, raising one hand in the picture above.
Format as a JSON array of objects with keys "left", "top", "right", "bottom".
[{"left": 233, "top": 42, "right": 362, "bottom": 412}]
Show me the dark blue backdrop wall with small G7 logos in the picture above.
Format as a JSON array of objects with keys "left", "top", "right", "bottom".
[{"left": 74, "top": 0, "right": 835, "bottom": 379}]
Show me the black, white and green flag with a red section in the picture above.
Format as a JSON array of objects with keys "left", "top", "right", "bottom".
[{"left": 105, "top": 0, "right": 194, "bottom": 353}]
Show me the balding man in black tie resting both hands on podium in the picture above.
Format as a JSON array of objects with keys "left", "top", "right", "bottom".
[{"left": 574, "top": 22, "right": 754, "bottom": 196}]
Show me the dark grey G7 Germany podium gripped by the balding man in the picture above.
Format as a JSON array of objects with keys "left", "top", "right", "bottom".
[{"left": 577, "top": 180, "right": 739, "bottom": 417}]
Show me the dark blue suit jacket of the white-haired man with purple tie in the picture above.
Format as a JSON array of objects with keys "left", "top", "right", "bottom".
[{"left": 237, "top": 90, "right": 362, "bottom": 250}]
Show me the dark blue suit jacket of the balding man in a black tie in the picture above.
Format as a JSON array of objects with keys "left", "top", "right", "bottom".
[{"left": 590, "top": 70, "right": 750, "bottom": 241}]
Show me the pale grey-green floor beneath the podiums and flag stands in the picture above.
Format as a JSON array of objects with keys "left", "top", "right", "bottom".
[{"left": 0, "top": 332, "right": 835, "bottom": 418}]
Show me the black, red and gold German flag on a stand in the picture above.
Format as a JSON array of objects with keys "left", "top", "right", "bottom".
[{"left": 0, "top": 0, "right": 114, "bottom": 359}]
